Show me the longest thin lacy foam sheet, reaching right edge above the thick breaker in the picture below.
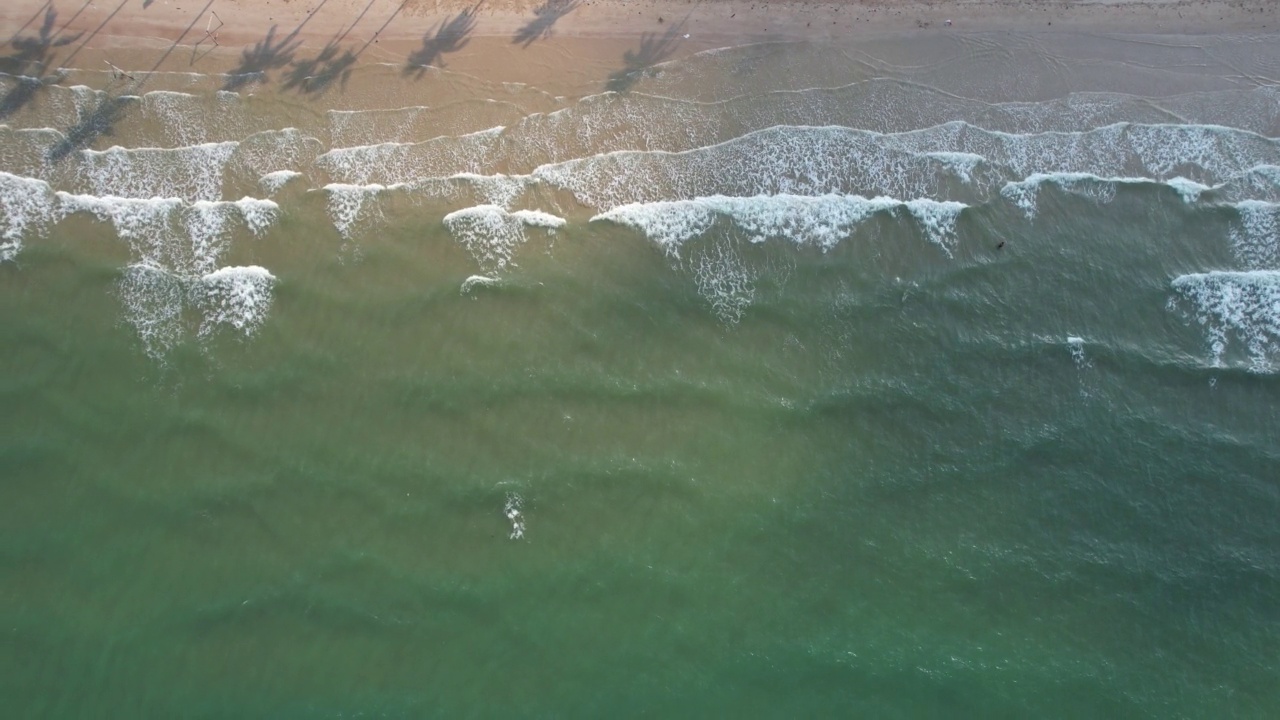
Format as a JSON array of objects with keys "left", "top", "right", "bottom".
[{"left": 532, "top": 122, "right": 1280, "bottom": 213}]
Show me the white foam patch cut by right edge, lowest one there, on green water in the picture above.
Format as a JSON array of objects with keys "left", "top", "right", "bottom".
[{"left": 1170, "top": 270, "right": 1280, "bottom": 373}]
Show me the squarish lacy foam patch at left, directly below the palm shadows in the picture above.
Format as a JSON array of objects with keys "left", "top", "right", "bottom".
[{"left": 79, "top": 142, "right": 239, "bottom": 201}]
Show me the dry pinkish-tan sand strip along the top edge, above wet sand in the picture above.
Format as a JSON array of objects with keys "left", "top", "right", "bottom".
[{"left": 0, "top": 0, "right": 1280, "bottom": 94}]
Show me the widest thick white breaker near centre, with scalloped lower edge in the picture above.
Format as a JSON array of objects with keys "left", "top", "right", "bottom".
[{"left": 591, "top": 195, "right": 966, "bottom": 255}]
